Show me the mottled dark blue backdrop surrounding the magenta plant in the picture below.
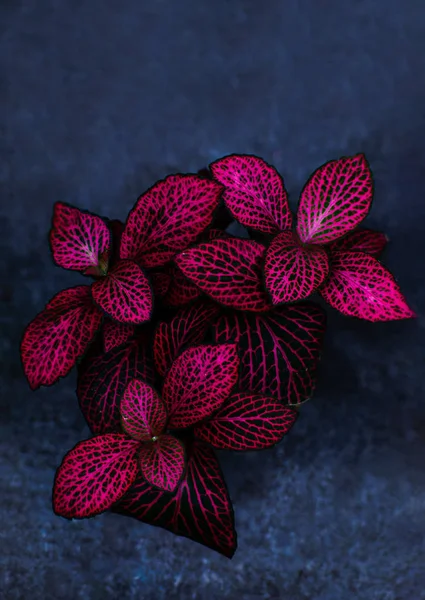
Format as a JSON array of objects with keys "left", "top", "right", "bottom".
[{"left": 0, "top": 0, "right": 425, "bottom": 600}]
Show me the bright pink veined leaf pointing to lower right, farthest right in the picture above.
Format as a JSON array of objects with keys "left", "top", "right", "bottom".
[{"left": 319, "top": 252, "right": 416, "bottom": 321}]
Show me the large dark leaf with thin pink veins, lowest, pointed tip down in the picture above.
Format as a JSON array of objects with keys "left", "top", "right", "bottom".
[{"left": 112, "top": 441, "right": 237, "bottom": 558}]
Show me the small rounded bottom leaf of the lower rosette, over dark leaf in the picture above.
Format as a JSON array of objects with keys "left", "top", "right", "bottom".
[{"left": 139, "top": 434, "right": 186, "bottom": 492}]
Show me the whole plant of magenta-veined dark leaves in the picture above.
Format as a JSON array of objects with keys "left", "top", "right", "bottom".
[{"left": 21, "top": 154, "right": 414, "bottom": 557}]
